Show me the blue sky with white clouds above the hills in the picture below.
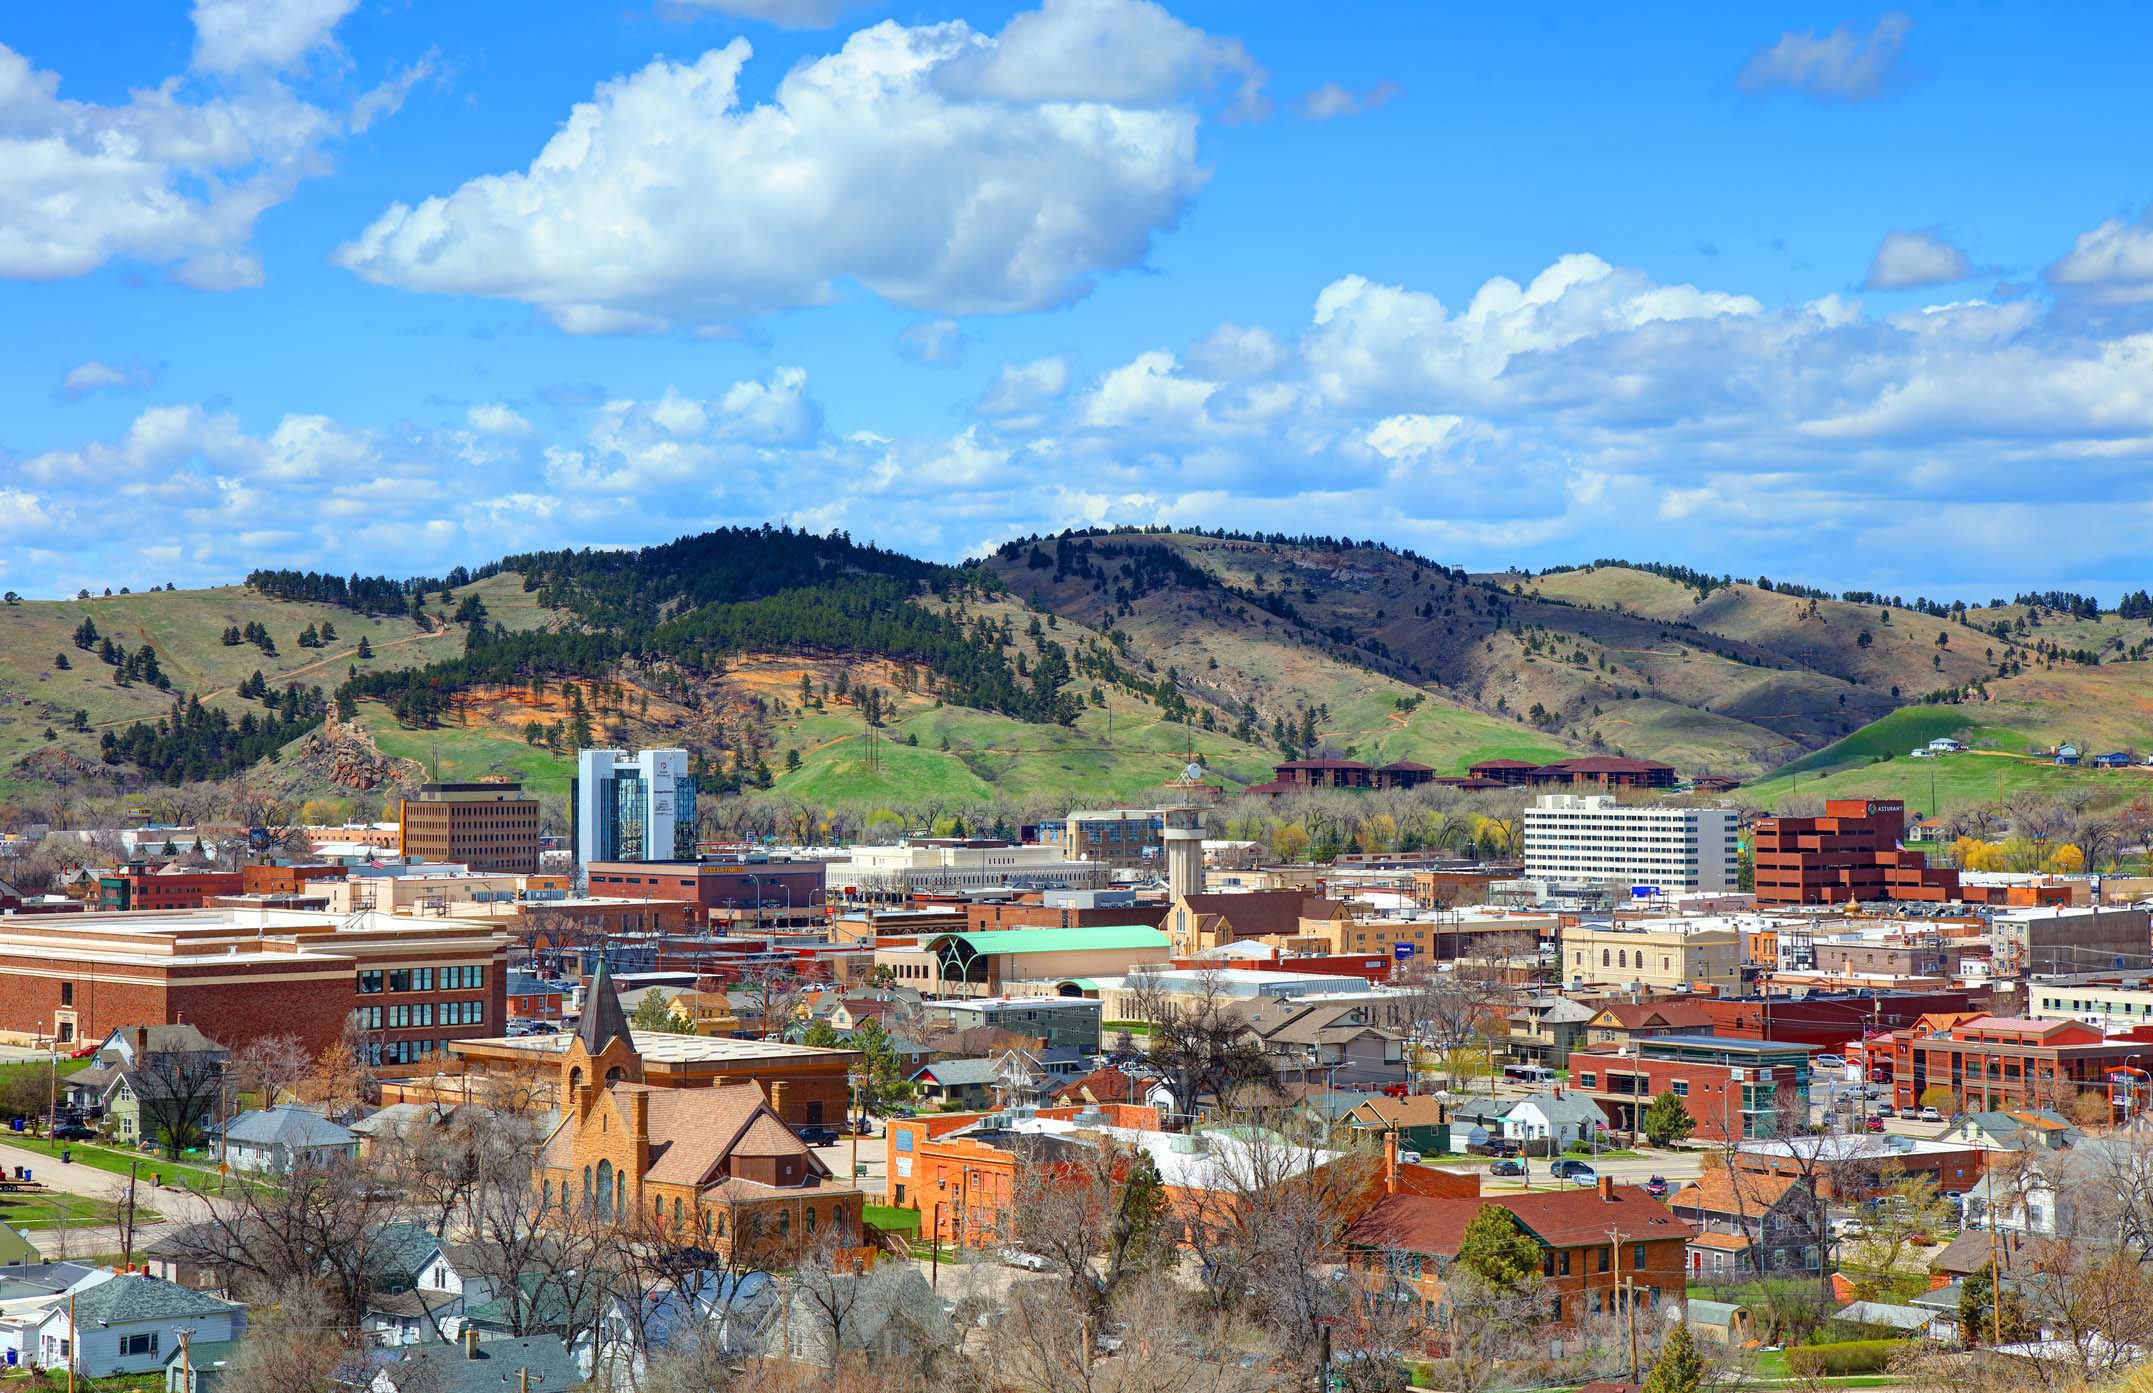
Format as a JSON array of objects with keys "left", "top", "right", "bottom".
[{"left": 0, "top": 0, "right": 2153, "bottom": 599}]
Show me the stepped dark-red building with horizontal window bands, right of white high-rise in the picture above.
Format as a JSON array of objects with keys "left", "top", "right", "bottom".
[{"left": 1755, "top": 799, "right": 1959, "bottom": 904}]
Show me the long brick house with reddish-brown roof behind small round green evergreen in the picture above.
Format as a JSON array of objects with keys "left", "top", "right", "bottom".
[{"left": 1346, "top": 1178, "right": 1697, "bottom": 1324}]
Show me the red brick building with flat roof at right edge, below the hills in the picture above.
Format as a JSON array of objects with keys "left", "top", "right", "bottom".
[{"left": 1890, "top": 1016, "right": 2153, "bottom": 1113}]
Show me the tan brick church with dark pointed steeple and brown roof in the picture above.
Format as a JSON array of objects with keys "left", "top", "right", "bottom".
[{"left": 538, "top": 962, "right": 861, "bottom": 1260}]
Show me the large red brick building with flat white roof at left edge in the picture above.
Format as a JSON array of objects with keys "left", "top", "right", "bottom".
[{"left": 0, "top": 908, "right": 508, "bottom": 1072}]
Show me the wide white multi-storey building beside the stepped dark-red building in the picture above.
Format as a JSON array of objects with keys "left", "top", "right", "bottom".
[{"left": 1524, "top": 792, "right": 1740, "bottom": 898}]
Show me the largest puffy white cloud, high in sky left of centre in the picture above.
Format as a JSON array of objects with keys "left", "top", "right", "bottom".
[{"left": 336, "top": 0, "right": 1225, "bottom": 334}]
